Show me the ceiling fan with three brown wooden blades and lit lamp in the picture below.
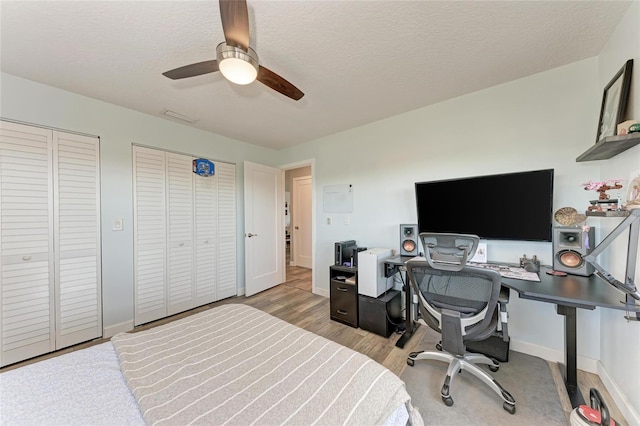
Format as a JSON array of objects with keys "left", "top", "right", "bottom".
[{"left": 162, "top": 0, "right": 304, "bottom": 101}]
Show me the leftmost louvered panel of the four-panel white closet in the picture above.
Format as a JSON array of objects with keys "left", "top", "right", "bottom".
[{"left": 133, "top": 146, "right": 167, "bottom": 325}]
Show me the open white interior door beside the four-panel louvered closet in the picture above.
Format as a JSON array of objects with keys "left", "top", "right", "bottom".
[{"left": 244, "top": 161, "right": 284, "bottom": 296}]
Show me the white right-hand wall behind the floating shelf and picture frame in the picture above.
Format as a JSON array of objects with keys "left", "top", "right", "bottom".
[{"left": 596, "top": 1, "right": 640, "bottom": 425}]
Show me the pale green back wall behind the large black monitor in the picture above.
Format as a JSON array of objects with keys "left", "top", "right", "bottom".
[{"left": 282, "top": 58, "right": 601, "bottom": 362}]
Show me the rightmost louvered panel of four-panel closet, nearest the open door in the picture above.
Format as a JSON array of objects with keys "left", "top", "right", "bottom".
[{"left": 216, "top": 163, "right": 237, "bottom": 300}]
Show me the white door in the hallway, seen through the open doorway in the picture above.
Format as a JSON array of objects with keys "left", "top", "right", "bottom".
[{"left": 292, "top": 176, "right": 312, "bottom": 268}]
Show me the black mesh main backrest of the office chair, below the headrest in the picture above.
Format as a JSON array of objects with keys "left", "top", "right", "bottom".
[{"left": 406, "top": 260, "right": 501, "bottom": 350}]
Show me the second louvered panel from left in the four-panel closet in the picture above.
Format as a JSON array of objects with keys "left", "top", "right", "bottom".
[{"left": 166, "top": 153, "right": 196, "bottom": 315}]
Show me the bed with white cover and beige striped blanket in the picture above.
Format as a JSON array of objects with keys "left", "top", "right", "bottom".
[{"left": 0, "top": 304, "right": 422, "bottom": 425}]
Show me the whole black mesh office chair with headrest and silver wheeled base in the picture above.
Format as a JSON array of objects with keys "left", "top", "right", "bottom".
[{"left": 406, "top": 233, "right": 516, "bottom": 414}]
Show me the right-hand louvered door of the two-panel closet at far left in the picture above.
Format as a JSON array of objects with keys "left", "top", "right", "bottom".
[{"left": 53, "top": 132, "right": 102, "bottom": 349}]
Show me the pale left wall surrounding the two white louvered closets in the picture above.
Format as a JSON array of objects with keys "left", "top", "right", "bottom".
[{"left": 0, "top": 73, "right": 277, "bottom": 331}]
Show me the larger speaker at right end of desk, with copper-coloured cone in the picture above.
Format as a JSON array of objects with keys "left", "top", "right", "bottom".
[{"left": 553, "top": 226, "right": 596, "bottom": 277}]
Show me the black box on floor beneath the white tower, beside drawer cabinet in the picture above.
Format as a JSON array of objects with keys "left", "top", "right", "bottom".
[{"left": 358, "top": 290, "right": 402, "bottom": 337}]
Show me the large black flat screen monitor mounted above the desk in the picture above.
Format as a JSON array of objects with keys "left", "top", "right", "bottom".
[{"left": 415, "top": 169, "right": 553, "bottom": 241}]
